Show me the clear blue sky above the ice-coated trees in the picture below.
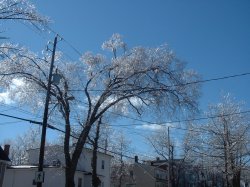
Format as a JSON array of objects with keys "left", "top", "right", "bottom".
[{"left": 0, "top": 0, "right": 250, "bottom": 159}]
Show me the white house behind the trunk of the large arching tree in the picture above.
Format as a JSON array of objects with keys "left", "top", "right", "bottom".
[{"left": 3, "top": 145, "right": 112, "bottom": 187}]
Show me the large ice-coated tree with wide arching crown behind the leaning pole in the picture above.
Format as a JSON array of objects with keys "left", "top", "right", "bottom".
[{"left": 0, "top": 34, "right": 199, "bottom": 187}]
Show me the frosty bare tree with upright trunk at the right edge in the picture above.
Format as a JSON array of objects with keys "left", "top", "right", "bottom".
[{"left": 188, "top": 95, "right": 250, "bottom": 187}]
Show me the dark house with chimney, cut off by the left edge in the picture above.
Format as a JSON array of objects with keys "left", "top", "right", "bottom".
[{"left": 0, "top": 145, "right": 10, "bottom": 187}]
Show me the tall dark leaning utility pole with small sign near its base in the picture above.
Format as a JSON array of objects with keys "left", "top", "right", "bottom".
[{"left": 35, "top": 36, "right": 57, "bottom": 187}]
